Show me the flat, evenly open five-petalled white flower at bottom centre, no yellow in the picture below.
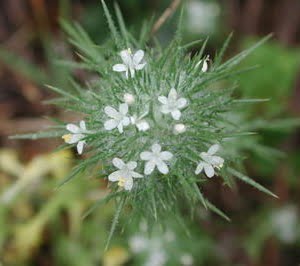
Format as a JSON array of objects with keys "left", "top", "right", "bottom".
[{"left": 140, "top": 144, "right": 173, "bottom": 175}]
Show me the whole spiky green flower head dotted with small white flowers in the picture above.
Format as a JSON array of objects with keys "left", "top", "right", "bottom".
[{"left": 11, "top": 2, "right": 284, "bottom": 248}]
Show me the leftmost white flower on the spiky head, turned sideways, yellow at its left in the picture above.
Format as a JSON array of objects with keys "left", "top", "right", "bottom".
[{"left": 62, "top": 121, "right": 88, "bottom": 154}]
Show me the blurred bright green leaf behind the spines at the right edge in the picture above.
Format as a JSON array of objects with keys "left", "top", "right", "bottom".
[{"left": 239, "top": 39, "right": 300, "bottom": 117}]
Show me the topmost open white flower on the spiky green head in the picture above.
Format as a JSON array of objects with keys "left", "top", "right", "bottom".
[{"left": 113, "top": 48, "right": 146, "bottom": 78}]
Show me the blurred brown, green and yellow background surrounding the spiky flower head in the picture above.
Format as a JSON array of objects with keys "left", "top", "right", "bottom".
[{"left": 0, "top": 0, "right": 300, "bottom": 266}]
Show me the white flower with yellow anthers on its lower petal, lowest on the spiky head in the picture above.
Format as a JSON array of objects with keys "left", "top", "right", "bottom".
[{"left": 108, "top": 158, "right": 143, "bottom": 190}]
